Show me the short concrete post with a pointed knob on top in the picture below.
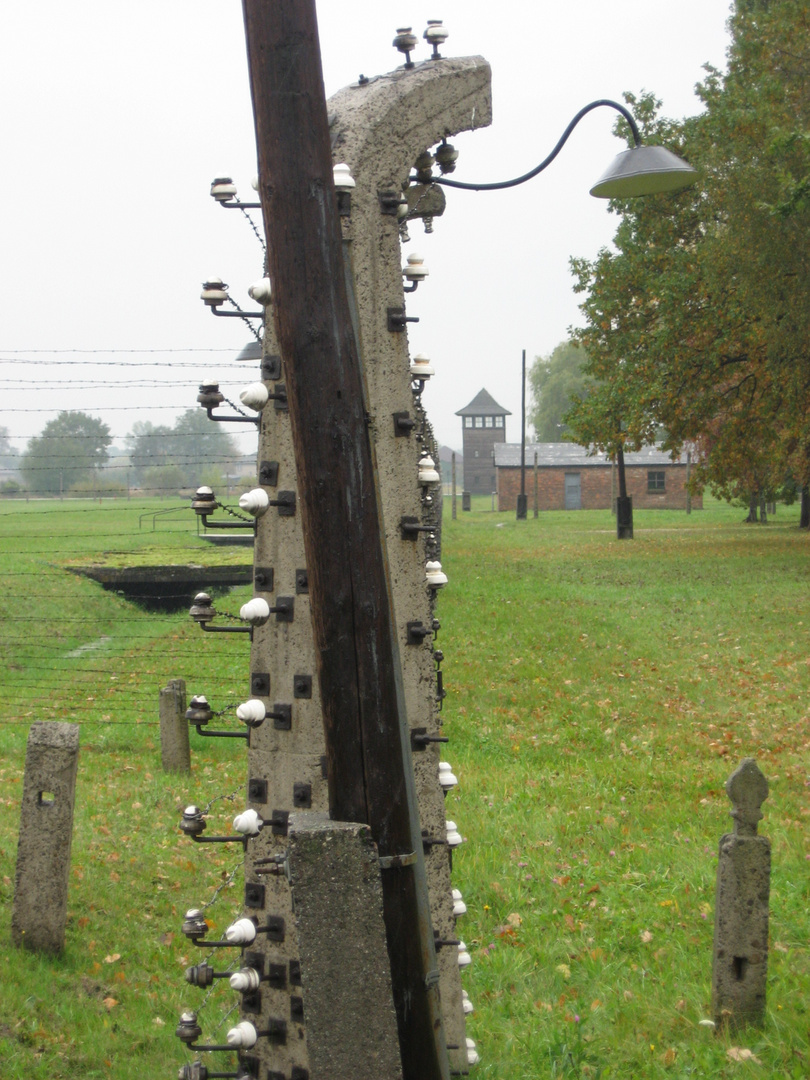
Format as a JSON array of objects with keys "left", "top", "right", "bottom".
[{"left": 712, "top": 757, "right": 771, "bottom": 1029}]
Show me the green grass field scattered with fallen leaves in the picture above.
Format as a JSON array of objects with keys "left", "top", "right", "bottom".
[{"left": 0, "top": 500, "right": 810, "bottom": 1080}]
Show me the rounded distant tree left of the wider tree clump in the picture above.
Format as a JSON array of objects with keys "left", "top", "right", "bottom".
[{"left": 19, "top": 413, "right": 112, "bottom": 495}]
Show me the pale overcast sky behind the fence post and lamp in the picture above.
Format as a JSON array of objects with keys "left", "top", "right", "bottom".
[{"left": 0, "top": 0, "right": 729, "bottom": 449}]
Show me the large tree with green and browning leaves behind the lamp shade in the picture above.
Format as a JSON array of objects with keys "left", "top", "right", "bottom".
[{"left": 569, "top": 0, "right": 810, "bottom": 518}]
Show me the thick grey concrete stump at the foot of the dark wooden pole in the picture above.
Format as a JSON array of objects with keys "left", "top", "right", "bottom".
[{"left": 288, "top": 813, "right": 402, "bottom": 1080}]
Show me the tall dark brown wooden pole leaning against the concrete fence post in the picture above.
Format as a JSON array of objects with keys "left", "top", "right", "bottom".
[{"left": 243, "top": 0, "right": 449, "bottom": 1080}]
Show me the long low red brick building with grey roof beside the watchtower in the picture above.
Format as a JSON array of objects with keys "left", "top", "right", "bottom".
[{"left": 495, "top": 443, "right": 703, "bottom": 510}]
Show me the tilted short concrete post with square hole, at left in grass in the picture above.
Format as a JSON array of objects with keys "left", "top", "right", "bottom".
[{"left": 11, "top": 721, "right": 79, "bottom": 953}]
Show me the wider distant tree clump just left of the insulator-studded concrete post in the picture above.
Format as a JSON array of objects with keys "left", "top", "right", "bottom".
[{"left": 127, "top": 408, "right": 240, "bottom": 491}]
